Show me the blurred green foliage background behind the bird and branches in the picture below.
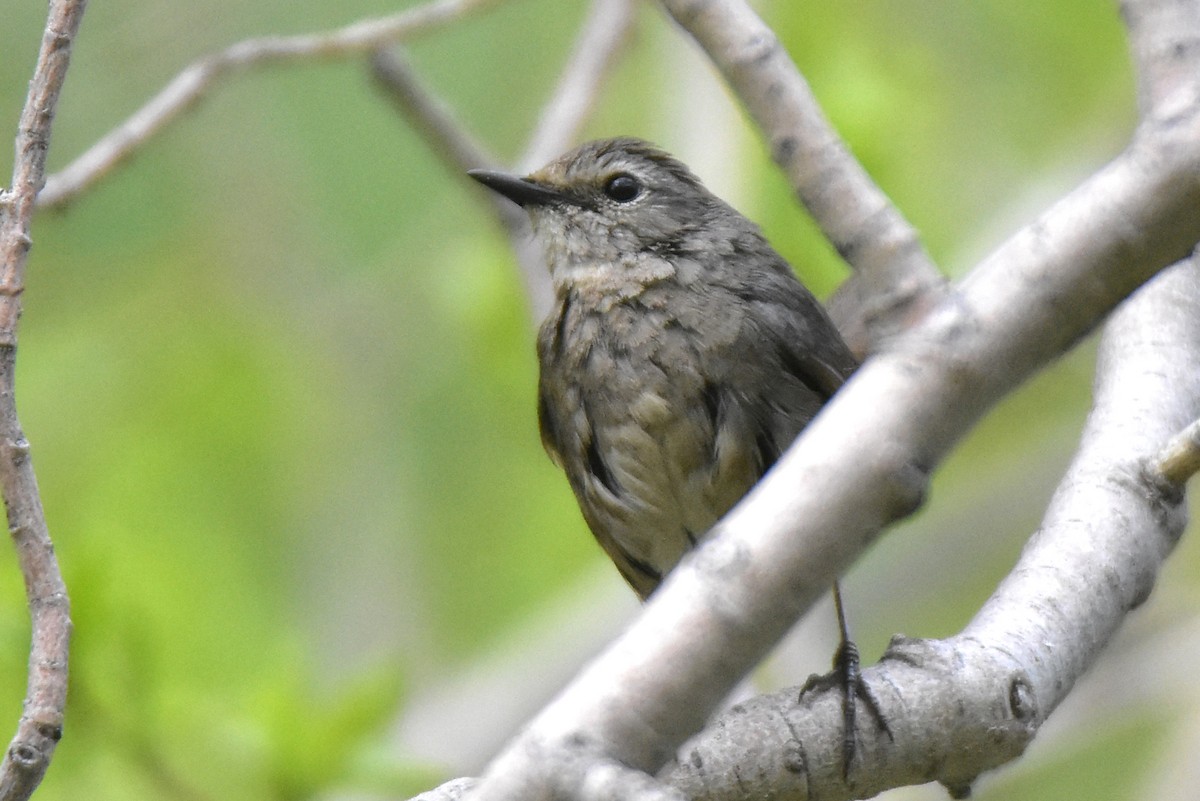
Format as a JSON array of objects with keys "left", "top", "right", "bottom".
[{"left": 0, "top": 0, "right": 1200, "bottom": 801}]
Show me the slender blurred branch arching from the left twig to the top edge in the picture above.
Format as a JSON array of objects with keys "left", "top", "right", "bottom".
[{"left": 38, "top": 0, "right": 496, "bottom": 207}]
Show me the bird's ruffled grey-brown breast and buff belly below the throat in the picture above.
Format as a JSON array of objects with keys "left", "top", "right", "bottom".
[{"left": 539, "top": 290, "right": 757, "bottom": 574}]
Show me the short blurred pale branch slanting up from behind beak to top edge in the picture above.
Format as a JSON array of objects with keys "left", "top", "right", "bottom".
[{"left": 516, "top": 0, "right": 636, "bottom": 173}]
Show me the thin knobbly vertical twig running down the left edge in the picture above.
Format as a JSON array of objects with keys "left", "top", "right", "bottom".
[{"left": 0, "top": 0, "right": 86, "bottom": 801}]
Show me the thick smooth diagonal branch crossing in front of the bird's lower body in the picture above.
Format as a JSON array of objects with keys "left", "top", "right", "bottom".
[{"left": 458, "top": 61, "right": 1200, "bottom": 800}]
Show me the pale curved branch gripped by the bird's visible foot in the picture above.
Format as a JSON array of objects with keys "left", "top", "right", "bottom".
[{"left": 660, "top": 259, "right": 1200, "bottom": 801}]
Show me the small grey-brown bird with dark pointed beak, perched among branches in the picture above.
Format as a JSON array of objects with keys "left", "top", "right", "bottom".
[{"left": 468, "top": 138, "right": 886, "bottom": 773}]
